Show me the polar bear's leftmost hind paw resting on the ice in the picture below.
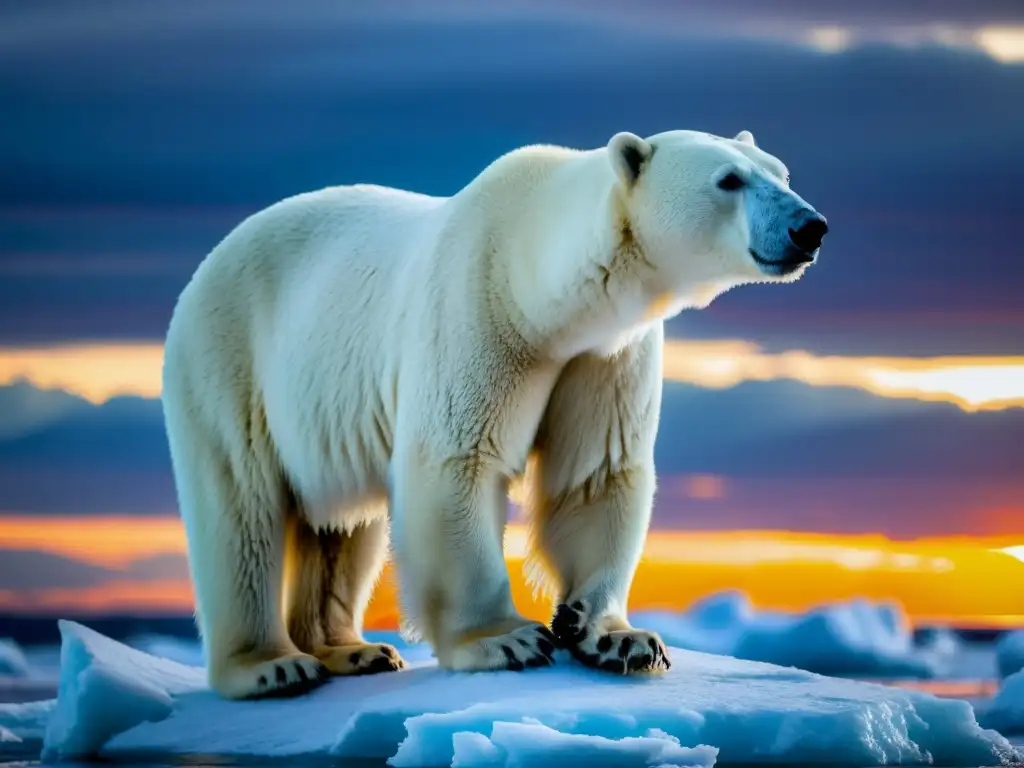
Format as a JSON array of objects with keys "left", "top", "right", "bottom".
[{"left": 211, "top": 653, "right": 328, "bottom": 698}]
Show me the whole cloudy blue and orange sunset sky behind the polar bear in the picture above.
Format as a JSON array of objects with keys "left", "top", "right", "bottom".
[{"left": 0, "top": 0, "right": 1024, "bottom": 624}]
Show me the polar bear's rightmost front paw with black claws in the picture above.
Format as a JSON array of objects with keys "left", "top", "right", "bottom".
[{"left": 551, "top": 600, "right": 672, "bottom": 675}]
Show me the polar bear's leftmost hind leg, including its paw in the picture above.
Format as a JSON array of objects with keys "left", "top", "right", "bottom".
[{"left": 169, "top": 428, "right": 327, "bottom": 698}]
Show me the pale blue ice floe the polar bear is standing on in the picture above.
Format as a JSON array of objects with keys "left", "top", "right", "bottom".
[{"left": 32, "top": 622, "right": 1022, "bottom": 768}]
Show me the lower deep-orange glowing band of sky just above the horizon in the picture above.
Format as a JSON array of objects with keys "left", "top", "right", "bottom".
[{"left": 0, "top": 517, "right": 1024, "bottom": 629}]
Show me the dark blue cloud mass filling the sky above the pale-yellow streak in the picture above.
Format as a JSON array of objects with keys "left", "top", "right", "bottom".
[{"left": 0, "top": 0, "right": 1024, "bottom": 354}]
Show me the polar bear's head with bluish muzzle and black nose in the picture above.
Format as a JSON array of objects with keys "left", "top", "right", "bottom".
[{"left": 607, "top": 131, "right": 828, "bottom": 304}]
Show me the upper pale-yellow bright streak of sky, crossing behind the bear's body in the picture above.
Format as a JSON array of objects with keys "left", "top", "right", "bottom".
[{"left": 0, "top": 339, "right": 1024, "bottom": 412}]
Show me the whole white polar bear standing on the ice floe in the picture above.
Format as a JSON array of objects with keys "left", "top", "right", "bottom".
[{"left": 163, "top": 130, "right": 827, "bottom": 698}]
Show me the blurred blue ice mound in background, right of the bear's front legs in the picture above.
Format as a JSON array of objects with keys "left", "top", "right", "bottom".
[{"left": 630, "top": 592, "right": 956, "bottom": 678}]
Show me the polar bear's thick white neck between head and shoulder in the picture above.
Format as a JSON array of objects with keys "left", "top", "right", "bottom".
[{"left": 485, "top": 147, "right": 660, "bottom": 359}]
